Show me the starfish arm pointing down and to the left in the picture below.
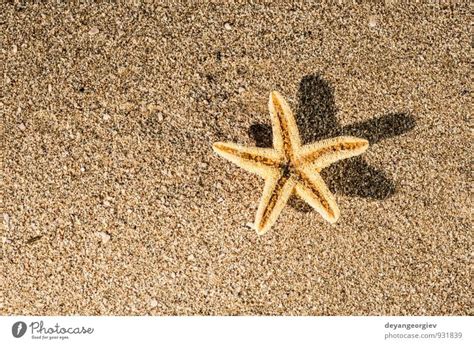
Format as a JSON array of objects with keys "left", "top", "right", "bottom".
[{"left": 255, "top": 172, "right": 295, "bottom": 235}]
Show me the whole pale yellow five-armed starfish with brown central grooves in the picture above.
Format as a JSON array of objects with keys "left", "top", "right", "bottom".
[{"left": 212, "top": 91, "right": 369, "bottom": 235}]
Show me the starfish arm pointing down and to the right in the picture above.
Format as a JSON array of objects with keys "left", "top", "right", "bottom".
[{"left": 295, "top": 167, "right": 340, "bottom": 223}]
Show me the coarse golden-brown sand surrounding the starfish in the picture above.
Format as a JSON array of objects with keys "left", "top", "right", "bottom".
[{"left": 0, "top": 1, "right": 473, "bottom": 315}]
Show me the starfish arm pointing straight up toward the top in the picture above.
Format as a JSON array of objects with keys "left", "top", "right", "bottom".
[{"left": 268, "top": 91, "right": 301, "bottom": 160}]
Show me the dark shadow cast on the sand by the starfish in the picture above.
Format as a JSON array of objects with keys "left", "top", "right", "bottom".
[{"left": 249, "top": 74, "right": 415, "bottom": 212}]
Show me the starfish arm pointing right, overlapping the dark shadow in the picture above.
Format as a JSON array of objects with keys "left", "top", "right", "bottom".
[{"left": 298, "top": 136, "right": 369, "bottom": 169}]
